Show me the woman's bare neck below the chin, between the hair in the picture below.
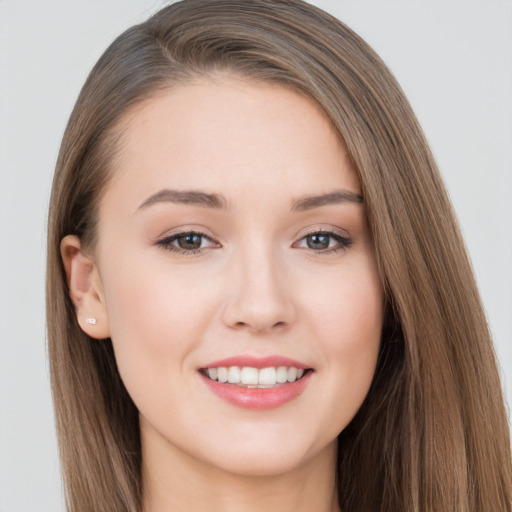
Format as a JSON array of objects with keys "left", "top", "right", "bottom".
[{"left": 143, "top": 426, "right": 339, "bottom": 512}]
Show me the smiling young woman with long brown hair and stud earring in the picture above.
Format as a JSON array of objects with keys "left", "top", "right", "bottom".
[{"left": 47, "top": 0, "right": 512, "bottom": 512}]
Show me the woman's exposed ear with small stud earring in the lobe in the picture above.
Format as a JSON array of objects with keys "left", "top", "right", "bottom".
[{"left": 60, "top": 235, "right": 110, "bottom": 339}]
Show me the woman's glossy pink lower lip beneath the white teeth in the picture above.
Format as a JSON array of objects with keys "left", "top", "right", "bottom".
[{"left": 200, "top": 371, "right": 313, "bottom": 410}]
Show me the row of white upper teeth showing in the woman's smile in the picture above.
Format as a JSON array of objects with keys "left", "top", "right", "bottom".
[{"left": 206, "top": 366, "right": 304, "bottom": 387}]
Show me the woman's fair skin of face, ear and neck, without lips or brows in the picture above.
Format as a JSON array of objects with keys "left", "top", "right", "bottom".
[{"left": 62, "top": 76, "right": 384, "bottom": 512}]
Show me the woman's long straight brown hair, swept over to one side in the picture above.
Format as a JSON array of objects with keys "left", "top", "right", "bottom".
[{"left": 47, "top": 0, "right": 512, "bottom": 512}]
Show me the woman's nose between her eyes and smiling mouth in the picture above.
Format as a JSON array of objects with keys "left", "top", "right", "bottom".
[{"left": 223, "top": 245, "right": 296, "bottom": 334}]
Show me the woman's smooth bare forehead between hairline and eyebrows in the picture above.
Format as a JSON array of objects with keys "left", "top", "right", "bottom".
[{"left": 106, "top": 77, "right": 360, "bottom": 210}]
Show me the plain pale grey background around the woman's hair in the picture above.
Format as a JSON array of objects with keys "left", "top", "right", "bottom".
[{"left": 0, "top": 0, "right": 512, "bottom": 512}]
